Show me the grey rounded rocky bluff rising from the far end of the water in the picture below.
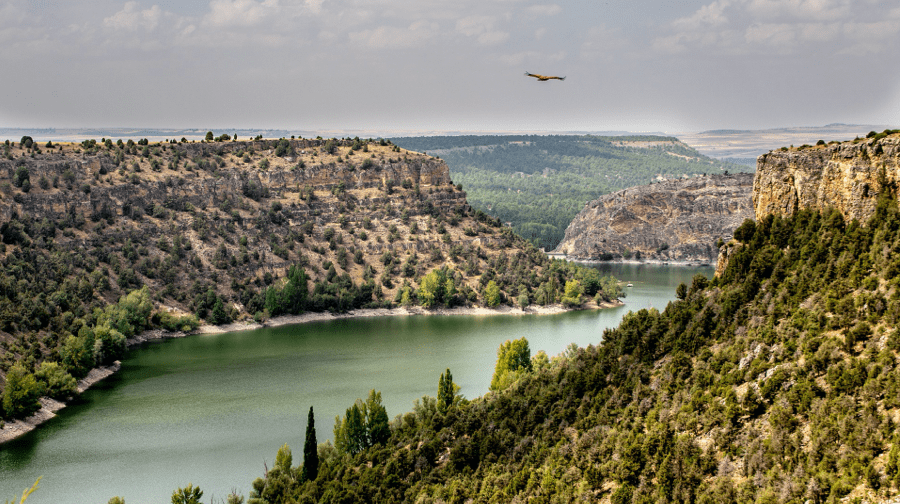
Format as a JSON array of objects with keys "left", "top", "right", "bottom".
[{"left": 554, "top": 173, "right": 753, "bottom": 263}]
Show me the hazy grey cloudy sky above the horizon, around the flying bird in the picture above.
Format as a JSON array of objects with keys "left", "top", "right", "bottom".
[{"left": 0, "top": 0, "right": 900, "bottom": 132}]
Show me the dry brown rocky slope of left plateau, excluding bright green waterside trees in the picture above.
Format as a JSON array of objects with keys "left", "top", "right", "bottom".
[{"left": 0, "top": 139, "right": 560, "bottom": 342}]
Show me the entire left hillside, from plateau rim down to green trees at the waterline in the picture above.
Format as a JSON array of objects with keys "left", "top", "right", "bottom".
[{"left": 0, "top": 135, "right": 617, "bottom": 426}]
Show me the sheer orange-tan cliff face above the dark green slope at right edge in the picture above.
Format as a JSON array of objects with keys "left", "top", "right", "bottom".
[{"left": 753, "top": 134, "right": 900, "bottom": 221}]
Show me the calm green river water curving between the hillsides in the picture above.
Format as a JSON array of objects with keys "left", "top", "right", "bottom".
[{"left": 0, "top": 264, "right": 712, "bottom": 504}]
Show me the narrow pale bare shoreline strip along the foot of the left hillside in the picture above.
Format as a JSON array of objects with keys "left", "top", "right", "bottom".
[{"left": 0, "top": 300, "right": 625, "bottom": 446}]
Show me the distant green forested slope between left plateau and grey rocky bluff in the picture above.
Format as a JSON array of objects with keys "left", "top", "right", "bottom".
[{"left": 392, "top": 135, "right": 754, "bottom": 250}]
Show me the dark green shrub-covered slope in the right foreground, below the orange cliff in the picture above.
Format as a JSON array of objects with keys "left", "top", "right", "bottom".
[{"left": 230, "top": 128, "right": 900, "bottom": 504}]
